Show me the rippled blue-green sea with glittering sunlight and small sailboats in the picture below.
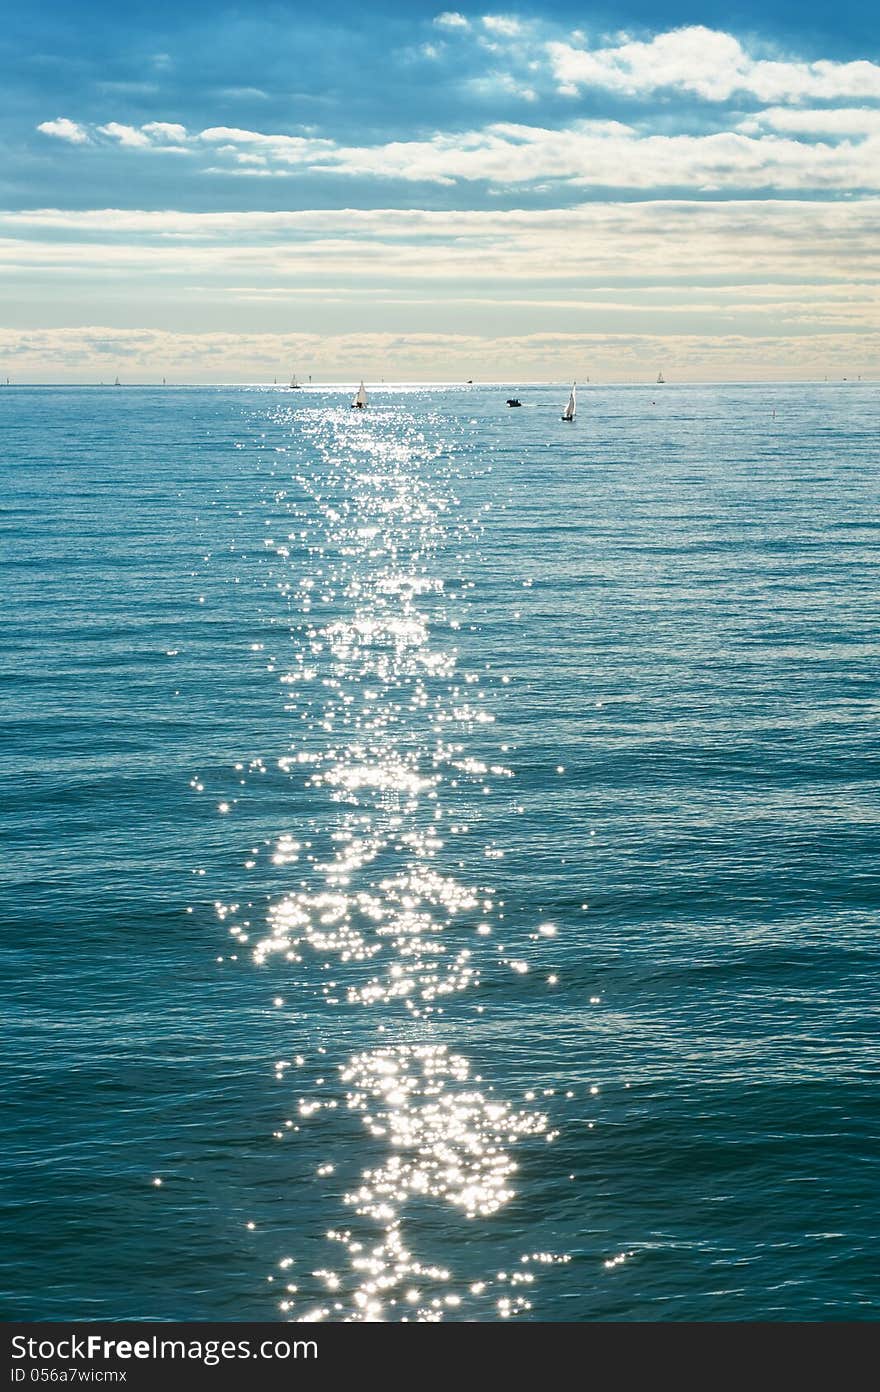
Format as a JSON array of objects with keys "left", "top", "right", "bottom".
[{"left": 0, "top": 381, "right": 880, "bottom": 1321}]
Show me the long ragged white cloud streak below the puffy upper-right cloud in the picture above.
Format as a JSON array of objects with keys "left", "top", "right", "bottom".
[{"left": 39, "top": 107, "right": 880, "bottom": 192}]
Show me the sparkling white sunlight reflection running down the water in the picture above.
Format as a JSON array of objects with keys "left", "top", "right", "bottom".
[{"left": 214, "top": 404, "right": 565, "bottom": 1321}]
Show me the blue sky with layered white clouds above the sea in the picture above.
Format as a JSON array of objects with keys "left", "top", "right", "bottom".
[{"left": 0, "top": 0, "right": 880, "bottom": 381}]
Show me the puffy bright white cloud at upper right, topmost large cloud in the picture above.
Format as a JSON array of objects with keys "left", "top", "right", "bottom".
[{"left": 547, "top": 25, "right": 880, "bottom": 102}]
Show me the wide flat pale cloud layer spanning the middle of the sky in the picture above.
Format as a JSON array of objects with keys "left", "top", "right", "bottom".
[{"left": 0, "top": 198, "right": 880, "bottom": 286}]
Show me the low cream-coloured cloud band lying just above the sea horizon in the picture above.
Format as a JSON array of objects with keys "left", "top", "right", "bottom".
[{"left": 0, "top": 324, "right": 880, "bottom": 384}]
